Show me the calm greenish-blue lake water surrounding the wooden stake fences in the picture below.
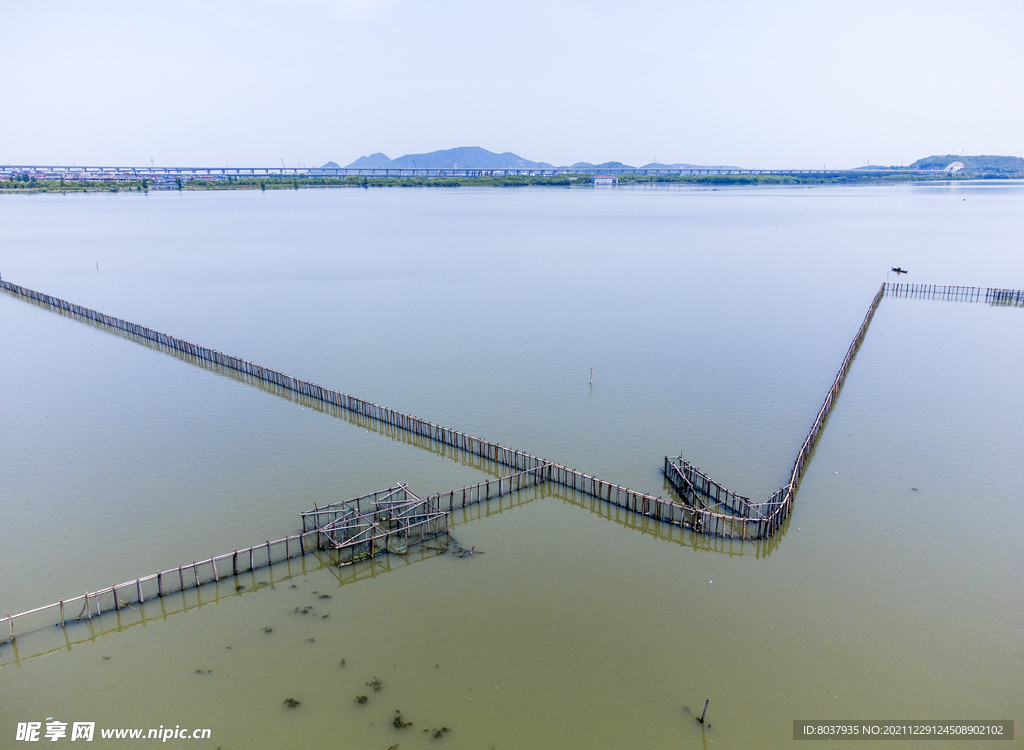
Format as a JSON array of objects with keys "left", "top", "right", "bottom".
[{"left": 0, "top": 184, "right": 1024, "bottom": 750}]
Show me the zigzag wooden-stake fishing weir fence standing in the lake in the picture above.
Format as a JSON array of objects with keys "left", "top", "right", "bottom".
[{"left": 0, "top": 279, "right": 1024, "bottom": 644}]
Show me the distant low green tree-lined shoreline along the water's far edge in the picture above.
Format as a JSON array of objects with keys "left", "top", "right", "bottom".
[{"left": 0, "top": 171, "right": 1024, "bottom": 194}]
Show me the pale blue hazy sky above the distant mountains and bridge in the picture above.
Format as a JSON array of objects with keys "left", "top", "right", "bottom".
[{"left": 0, "top": 0, "right": 1024, "bottom": 169}]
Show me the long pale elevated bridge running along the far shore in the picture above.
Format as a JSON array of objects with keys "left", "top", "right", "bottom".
[{"left": 0, "top": 164, "right": 945, "bottom": 183}]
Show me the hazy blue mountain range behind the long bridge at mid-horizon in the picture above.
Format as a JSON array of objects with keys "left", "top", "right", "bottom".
[{"left": 310, "top": 145, "right": 739, "bottom": 174}]
